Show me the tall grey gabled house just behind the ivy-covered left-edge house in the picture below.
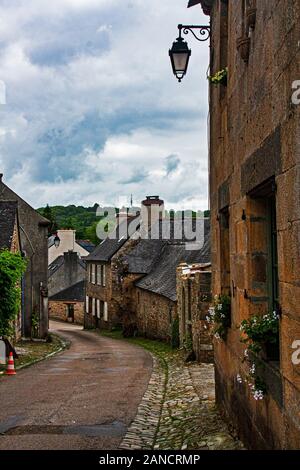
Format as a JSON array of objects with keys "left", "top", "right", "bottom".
[{"left": 0, "top": 174, "right": 49, "bottom": 338}]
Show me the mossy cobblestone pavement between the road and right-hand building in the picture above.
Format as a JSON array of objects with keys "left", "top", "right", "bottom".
[{"left": 121, "top": 353, "right": 243, "bottom": 450}]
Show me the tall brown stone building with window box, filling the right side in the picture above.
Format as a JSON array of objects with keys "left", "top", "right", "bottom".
[{"left": 190, "top": 0, "right": 300, "bottom": 449}]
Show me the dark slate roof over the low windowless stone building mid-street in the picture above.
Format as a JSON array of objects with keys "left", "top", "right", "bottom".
[{"left": 135, "top": 234, "right": 210, "bottom": 302}]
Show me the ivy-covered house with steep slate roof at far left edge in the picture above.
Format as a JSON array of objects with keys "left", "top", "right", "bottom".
[{"left": 0, "top": 201, "right": 22, "bottom": 339}]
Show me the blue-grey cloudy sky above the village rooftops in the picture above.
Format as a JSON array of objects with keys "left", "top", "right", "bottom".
[{"left": 0, "top": 0, "right": 208, "bottom": 209}]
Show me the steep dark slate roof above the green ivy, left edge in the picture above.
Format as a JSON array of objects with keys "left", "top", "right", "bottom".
[{"left": 0, "top": 201, "right": 18, "bottom": 249}]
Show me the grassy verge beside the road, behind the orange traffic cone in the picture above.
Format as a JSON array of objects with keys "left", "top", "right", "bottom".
[{"left": 0, "top": 334, "right": 66, "bottom": 372}]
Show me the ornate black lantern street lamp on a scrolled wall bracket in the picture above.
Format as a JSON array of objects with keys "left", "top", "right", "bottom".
[{"left": 169, "top": 24, "right": 210, "bottom": 82}]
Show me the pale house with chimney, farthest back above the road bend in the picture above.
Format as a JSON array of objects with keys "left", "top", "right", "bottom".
[{"left": 48, "top": 230, "right": 95, "bottom": 264}]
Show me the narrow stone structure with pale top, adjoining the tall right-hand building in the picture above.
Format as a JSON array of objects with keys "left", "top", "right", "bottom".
[{"left": 176, "top": 263, "right": 214, "bottom": 363}]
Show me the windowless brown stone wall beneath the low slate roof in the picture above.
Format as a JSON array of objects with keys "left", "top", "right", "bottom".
[{"left": 135, "top": 287, "right": 177, "bottom": 342}]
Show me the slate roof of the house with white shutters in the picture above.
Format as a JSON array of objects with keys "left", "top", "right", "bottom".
[{"left": 85, "top": 216, "right": 139, "bottom": 262}]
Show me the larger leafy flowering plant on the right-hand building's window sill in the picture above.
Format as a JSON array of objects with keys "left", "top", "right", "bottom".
[{"left": 240, "top": 312, "right": 279, "bottom": 354}]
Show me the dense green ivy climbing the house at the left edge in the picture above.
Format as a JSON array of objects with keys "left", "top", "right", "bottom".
[{"left": 0, "top": 250, "right": 26, "bottom": 337}]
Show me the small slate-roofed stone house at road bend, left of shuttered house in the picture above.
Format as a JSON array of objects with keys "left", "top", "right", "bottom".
[{"left": 48, "top": 251, "right": 86, "bottom": 324}]
